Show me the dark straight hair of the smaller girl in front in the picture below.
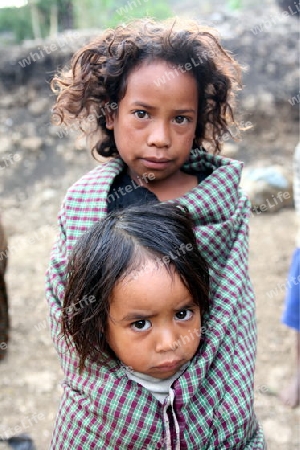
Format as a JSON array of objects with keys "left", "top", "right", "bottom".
[{"left": 62, "top": 203, "right": 209, "bottom": 371}]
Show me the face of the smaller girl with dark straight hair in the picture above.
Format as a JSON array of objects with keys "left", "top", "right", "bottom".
[{"left": 107, "top": 260, "right": 201, "bottom": 379}]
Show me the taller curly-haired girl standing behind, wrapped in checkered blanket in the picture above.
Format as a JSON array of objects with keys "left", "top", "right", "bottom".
[{"left": 47, "top": 16, "right": 264, "bottom": 450}]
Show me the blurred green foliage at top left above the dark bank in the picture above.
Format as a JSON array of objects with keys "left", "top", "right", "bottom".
[{"left": 0, "top": 0, "right": 172, "bottom": 42}]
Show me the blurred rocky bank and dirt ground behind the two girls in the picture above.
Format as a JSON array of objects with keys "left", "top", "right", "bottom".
[{"left": 0, "top": 0, "right": 300, "bottom": 450}]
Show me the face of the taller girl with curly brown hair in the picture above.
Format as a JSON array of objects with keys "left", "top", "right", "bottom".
[{"left": 106, "top": 61, "right": 198, "bottom": 184}]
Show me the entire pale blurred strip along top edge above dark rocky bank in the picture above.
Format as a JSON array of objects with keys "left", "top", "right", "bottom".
[{"left": 0, "top": 0, "right": 299, "bottom": 43}]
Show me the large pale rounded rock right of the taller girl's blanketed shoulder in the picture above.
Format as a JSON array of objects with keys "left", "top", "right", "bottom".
[{"left": 241, "top": 165, "right": 293, "bottom": 213}]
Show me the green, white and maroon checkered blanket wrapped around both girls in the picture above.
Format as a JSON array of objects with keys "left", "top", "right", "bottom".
[{"left": 47, "top": 151, "right": 266, "bottom": 450}]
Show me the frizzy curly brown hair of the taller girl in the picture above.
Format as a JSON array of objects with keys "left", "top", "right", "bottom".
[{"left": 51, "top": 19, "right": 241, "bottom": 157}]
